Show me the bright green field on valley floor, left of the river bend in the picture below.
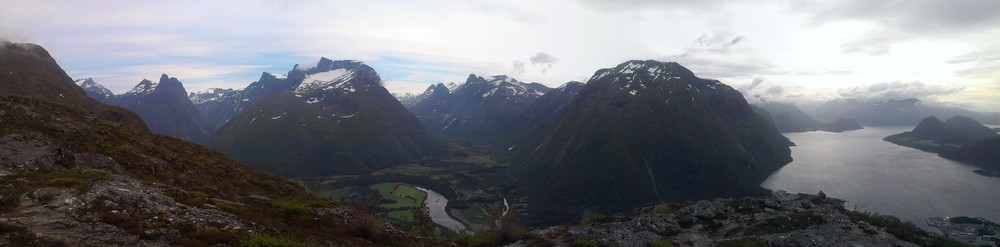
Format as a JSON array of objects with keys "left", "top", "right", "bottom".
[{"left": 369, "top": 183, "right": 427, "bottom": 222}]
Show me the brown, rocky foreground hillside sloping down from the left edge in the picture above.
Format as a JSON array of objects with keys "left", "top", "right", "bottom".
[{"left": 0, "top": 43, "right": 418, "bottom": 246}]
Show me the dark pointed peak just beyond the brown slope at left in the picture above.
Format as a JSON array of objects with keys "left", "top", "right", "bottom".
[{"left": 111, "top": 74, "right": 211, "bottom": 143}]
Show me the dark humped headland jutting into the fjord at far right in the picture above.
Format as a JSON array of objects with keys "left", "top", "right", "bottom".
[{"left": 883, "top": 116, "right": 1000, "bottom": 153}]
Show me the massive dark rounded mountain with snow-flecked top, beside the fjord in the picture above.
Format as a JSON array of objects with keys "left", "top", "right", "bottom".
[{"left": 515, "top": 60, "right": 791, "bottom": 224}]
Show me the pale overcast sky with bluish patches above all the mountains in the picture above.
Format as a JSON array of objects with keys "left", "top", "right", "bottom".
[{"left": 0, "top": 0, "right": 1000, "bottom": 111}]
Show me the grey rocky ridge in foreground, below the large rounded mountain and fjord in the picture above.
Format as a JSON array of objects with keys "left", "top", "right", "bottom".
[{"left": 511, "top": 192, "right": 954, "bottom": 246}]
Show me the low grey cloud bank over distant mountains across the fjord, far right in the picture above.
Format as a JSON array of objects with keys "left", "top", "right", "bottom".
[{"left": 837, "top": 81, "right": 965, "bottom": 100}]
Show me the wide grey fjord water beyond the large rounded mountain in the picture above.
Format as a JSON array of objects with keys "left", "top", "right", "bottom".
[{"left": 761, "top": 127, "right": 1000, "bottom": 230}]
